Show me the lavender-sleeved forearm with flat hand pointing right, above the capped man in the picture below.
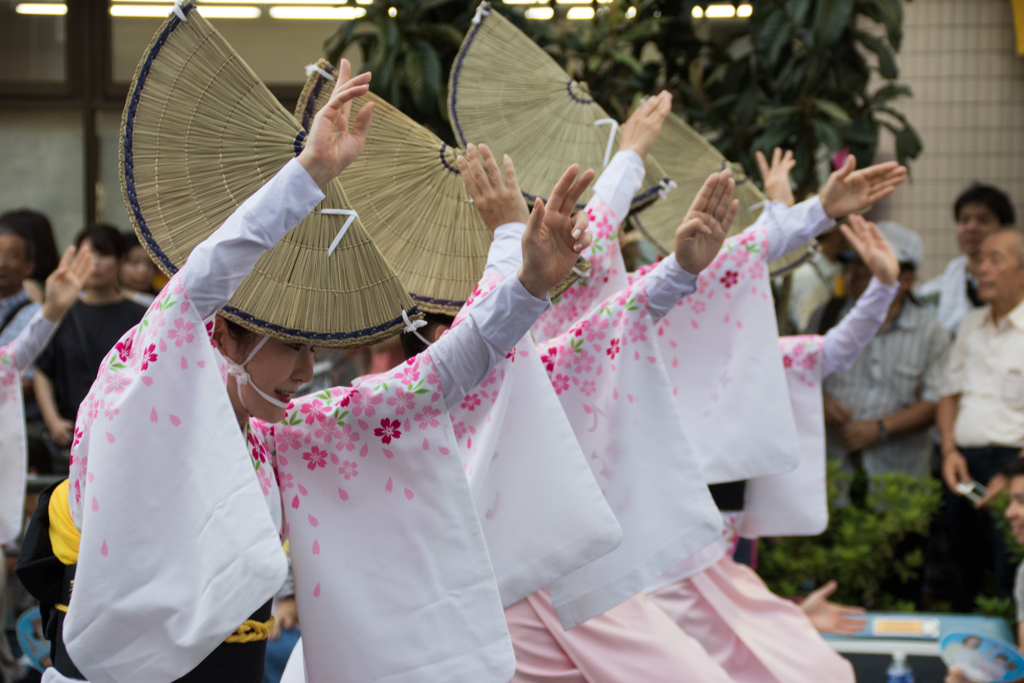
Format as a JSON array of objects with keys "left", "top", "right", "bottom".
[{"left": 755, "top": 155, "right": 906, "bottom": 261}]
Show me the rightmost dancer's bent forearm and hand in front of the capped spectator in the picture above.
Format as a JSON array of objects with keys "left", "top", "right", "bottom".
[{"left": 821, "top": 215, "right": 899, "bottom": 376}]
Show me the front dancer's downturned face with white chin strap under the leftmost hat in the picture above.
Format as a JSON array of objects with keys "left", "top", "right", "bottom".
[{"left": 213, "top": 316, "right": 313, "bottom": 424}]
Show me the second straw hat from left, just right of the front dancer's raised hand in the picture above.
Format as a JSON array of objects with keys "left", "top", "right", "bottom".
[{"left": 295, "top": 59, "right": 590, "bottom": 315}]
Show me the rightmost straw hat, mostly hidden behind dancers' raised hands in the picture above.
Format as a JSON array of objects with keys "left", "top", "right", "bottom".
[{"left": 630, "top": 113, "right": 807, "bottom": 274}]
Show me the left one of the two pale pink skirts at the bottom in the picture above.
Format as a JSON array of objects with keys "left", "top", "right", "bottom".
[{"left": 505, "top": 590, "right": 734, "bottom": 683}]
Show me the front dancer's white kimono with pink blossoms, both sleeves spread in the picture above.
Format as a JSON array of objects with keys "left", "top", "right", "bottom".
[{"left": 47, "top": 157, "right": 581, "bottom": 683}]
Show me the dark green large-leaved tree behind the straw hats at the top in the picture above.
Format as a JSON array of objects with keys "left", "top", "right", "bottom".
[{"left": 326, "top": 0, "right": 922, "bottom": 195}]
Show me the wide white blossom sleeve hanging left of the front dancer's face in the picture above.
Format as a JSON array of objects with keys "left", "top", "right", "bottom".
[{"left": 63, "top": 279, "right": 287, "bottom": 683}]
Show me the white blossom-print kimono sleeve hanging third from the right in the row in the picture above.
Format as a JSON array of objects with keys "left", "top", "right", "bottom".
[{"left": 540, "top": 272, "right": 722, "bottom": 629}]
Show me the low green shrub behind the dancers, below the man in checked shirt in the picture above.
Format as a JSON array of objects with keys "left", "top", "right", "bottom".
[{"left": 758, "top": 463, "right": 942, "bottom": 610}]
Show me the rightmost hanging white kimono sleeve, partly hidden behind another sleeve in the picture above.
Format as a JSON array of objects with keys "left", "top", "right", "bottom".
[{"left": 739, "top": 335, "right": 828, "bottom": 539}]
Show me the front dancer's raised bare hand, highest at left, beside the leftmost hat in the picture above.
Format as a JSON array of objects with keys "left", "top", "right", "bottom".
[{"left": 299, "top": 59, "right": 374, "bottom": 189}]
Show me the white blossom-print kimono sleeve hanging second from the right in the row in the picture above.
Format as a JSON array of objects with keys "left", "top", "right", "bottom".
[{"left": 657, "top": 226, "right": 797, "bottom": 483}]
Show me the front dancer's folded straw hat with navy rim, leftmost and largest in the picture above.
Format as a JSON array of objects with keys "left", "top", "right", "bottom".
[{"left": 121, "top": 4, "right": 417, "bottom": 348}]
